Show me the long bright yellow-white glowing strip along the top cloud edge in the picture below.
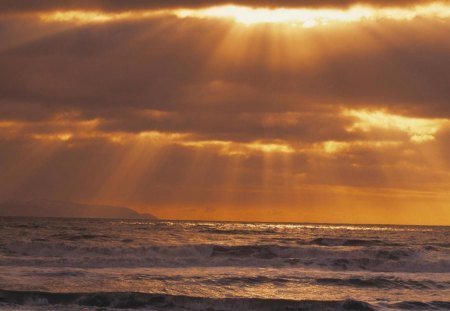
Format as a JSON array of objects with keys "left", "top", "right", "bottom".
[{"left": 40, "top": 2, "right": 450, "bottom": 28}]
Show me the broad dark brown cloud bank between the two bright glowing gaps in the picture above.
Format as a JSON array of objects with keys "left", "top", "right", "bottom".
[{"left": 0, "top": 17, "right": 450, "bottom": 133}]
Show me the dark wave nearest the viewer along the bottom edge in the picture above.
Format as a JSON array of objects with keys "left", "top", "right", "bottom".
[{"left": 0, "top": 290, "right": 375, "bottom": 311}]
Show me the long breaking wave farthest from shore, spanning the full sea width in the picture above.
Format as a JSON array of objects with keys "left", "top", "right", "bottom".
[{"left": 0, "top": 241, "right": 450, "bottom": 273}]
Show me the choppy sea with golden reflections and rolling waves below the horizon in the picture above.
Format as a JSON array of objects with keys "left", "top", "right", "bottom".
[{"left": 0, "top": 218, "right": 450, "bottom": 310}]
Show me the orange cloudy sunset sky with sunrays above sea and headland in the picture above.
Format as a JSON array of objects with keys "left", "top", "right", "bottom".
[{"left": 0, "top": 0, "right": 450, "bottom": 225}]
